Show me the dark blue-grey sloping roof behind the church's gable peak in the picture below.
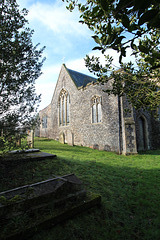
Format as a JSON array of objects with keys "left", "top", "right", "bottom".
[{"left": 65, "top": 66, "right": 97, "bottom": 87}]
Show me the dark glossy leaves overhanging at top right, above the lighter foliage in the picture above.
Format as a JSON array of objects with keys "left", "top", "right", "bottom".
[{"left": 64, "top": 0, "right": 160, "bottom": 67}]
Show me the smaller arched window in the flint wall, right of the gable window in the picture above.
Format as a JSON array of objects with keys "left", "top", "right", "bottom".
[{"left": 91, "top": 96, "right": 102, "bottom": 123}]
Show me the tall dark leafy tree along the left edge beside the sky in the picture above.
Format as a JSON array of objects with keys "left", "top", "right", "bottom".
[{"left": 0, "top": 0, "right": 44, "bottom": 148}]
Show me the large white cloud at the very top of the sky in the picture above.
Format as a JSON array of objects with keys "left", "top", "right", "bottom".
[{"left": 28, "top": 0, "right": 90, "bottom": 37}]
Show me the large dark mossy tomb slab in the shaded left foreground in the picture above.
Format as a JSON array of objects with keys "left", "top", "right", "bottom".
[{"left": 0, "top": 174, "right": 101, "bottom": 240}]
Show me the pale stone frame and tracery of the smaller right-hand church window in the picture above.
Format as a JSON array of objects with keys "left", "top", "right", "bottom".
[{"left": 91, "top": 95, "right": 102, "bottom": 124}]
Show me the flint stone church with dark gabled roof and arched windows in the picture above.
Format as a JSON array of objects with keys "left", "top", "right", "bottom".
[{"left": 39, "top": 64, "right": 160, "bottom": 155}]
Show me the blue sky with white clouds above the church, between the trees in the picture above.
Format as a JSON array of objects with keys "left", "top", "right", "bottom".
[{"left": 17, "top": 0, "right": 134, "bottom": 110}]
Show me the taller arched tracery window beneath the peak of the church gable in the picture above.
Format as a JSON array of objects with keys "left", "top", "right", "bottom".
[{"left": 59, "top": 89, "right": 70, "bottom": 126}]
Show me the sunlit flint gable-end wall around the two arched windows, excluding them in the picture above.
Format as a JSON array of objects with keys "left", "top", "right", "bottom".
[{"left": 41, "top": 64, "right": 119, "bottom": 152}]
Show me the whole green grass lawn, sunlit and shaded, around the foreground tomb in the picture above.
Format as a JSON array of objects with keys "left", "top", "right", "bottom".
[{"left": 0, "top": 138, "right": 160, "bottom": 240}]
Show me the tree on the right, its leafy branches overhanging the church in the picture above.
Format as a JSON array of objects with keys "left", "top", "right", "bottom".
[{"left": 63, "top": 0, "right": 160, "bottom": 111}]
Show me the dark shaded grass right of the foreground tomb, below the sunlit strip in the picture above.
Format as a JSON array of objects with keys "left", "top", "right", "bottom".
[{"left": 30, "top": 158, "right": 160, "bottom": 240}]
